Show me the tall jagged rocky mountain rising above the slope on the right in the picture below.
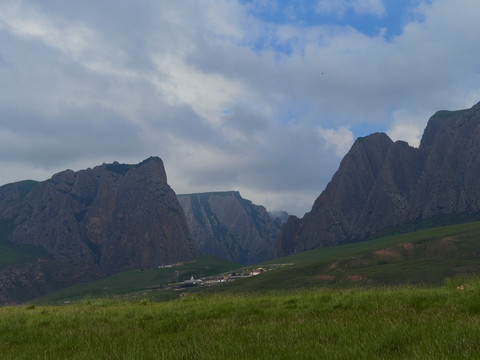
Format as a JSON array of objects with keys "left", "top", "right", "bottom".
[{"left": 274, "top": 104, "right": 480, "bottom": 256}]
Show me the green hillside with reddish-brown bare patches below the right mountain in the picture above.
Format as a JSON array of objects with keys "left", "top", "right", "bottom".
[{"left": 213, "top": 222, "right": 480, "bottom": 292}]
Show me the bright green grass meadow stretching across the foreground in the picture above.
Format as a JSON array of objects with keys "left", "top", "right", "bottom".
[{"left": 0, "top": 280, "right": 480, "bottom": 359}]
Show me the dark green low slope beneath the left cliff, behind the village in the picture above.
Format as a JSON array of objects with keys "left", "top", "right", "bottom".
[{"left": 32, "top": 255, "right": 241, "bottom": 304}]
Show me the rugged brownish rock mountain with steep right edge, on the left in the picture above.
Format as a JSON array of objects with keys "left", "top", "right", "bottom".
[{"left": 0, "top": 157, "right": 198, "bottom": 302}]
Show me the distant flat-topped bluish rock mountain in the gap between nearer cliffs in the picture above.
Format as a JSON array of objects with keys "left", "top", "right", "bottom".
[{"left": 178, "top": 191, "right": 281, "bottom": 264}]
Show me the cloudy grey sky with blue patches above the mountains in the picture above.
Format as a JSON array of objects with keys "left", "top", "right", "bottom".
[{"left": 0, "top": 0, "right": 480, "bottom": 216}]
